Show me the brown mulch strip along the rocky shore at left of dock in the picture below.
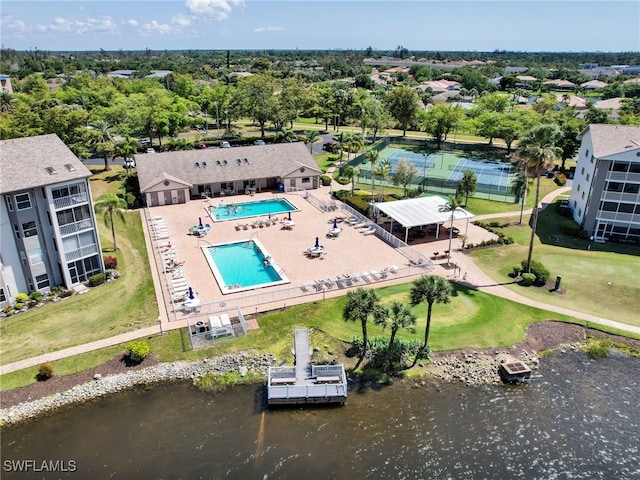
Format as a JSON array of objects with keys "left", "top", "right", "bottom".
[{"left": 0, "top": 353, "right": 160, "bottom": 408}]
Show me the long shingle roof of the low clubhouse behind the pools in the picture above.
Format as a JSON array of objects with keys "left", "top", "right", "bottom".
[{"left": 136, "top": 142, "right": 322, "bottom": 192}]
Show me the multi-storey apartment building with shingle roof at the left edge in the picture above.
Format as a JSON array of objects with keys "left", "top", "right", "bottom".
[{"left": 0, "top": 135, "right": 104, "bottom": 306}]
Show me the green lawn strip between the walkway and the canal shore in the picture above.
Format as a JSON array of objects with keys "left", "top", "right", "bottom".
[{"left": 0, "top": 283, "right": 579, "bottom": 390}]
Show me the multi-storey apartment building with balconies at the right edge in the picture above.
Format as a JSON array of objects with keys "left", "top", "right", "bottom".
[{"left": 569, "top": 124, "right": 640, "bottom": 244}]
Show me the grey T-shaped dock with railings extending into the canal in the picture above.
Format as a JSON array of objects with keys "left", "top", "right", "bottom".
[{"left": 267, "top": 328, "right": 347, "bottom": 405}]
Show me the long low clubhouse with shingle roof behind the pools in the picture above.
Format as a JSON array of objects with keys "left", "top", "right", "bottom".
[{"left": 136, "top": 142, "right": 322, "bottom": 207}]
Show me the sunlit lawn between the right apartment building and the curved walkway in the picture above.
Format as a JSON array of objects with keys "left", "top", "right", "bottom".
[{"left": 471, "top": 206, "right": 640, "bottom": 326}]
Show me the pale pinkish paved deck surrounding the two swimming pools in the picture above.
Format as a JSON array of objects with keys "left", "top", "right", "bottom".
[{"left": 141, "top": 187, "right": 494, "bottom": 328}]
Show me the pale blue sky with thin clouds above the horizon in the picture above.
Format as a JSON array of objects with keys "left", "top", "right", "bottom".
[{"left": 0, "top": 0, "right": 640, "bottom": 52}]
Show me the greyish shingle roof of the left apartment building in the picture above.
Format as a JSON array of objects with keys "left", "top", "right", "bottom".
[{"left": 0, "top": 134, "right": 91, "bottom": 193}]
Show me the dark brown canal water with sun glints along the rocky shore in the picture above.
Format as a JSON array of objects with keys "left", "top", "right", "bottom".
[{"left": 1, "top": 352, "right": 640, "bottom": 480}]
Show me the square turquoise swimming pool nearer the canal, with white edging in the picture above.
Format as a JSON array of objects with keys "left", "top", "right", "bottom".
[{"left": 201, "top": 239, "right": 289, "bottom": 294}]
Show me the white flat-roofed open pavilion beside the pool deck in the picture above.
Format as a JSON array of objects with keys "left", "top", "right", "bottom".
[{"left": 373, "top": 195, "right": 475, "bottom": 243}]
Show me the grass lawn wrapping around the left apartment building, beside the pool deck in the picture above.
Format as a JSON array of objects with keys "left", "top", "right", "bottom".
[{"left": 0, "top": 168, "right": 158, "bottom": 364}]
